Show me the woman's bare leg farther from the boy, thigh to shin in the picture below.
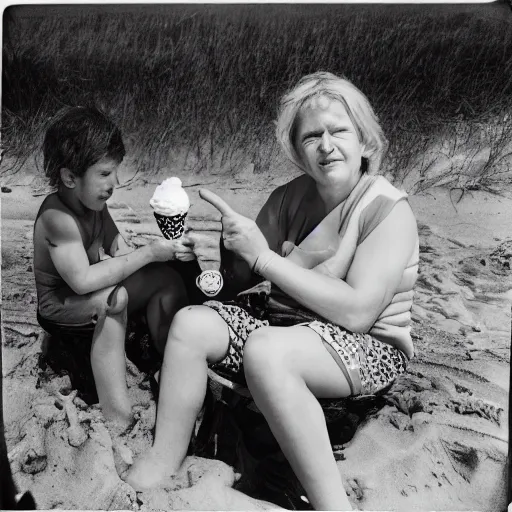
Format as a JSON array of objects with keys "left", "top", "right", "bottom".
[{"left": 244, "top": 326, "right": 352, "bottom": 510}]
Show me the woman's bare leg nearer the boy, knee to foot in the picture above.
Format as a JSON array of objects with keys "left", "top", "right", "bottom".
[{"left": 126, "top": 306, "right": 229, "bottom": 490}]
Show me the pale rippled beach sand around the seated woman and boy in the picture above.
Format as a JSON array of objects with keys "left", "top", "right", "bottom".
[{"left": 1, "top": 165, "right": 512, "bottom": 511}]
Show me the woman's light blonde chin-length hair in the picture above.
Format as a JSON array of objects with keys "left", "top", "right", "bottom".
[{"left": 276, "top": 71, "right": 387, "bottom": 174}]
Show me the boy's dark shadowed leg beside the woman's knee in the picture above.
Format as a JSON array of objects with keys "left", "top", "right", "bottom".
[{"left": 123, "top": 263, "right": 188, "bottom": 354}]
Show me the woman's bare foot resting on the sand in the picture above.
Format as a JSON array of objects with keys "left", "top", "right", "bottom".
[{"left": 124, "top": 450, "right": 179, "bottom": 491}]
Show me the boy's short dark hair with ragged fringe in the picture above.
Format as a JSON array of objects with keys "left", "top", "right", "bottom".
[{"left": 43, "top": 107, "right": 125, "bottom": 187}]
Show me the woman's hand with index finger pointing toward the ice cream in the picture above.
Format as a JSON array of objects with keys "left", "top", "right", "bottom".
[{"left": 199, "top": 189, "right": 269, "bottom": 268}]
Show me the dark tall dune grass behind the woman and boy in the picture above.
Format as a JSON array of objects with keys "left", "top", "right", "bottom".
[{"left": 1, "top": 4, "right": 512, "bottom": 191}]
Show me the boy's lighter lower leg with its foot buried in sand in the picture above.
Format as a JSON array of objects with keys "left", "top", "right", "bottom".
[{"left": 91, "top": 286, "right": 133, "bottom": 429}]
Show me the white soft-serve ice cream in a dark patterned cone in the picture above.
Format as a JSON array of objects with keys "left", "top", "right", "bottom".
[{"left": 149, "top": 177, "right": 190, "bottom": 240}]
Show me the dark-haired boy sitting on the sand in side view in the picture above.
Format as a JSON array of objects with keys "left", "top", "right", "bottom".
[{"left": 34, "top": 107, "right": 193, "bottom": 429}]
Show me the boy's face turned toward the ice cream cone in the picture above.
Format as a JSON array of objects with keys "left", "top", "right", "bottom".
[{"left": 74, "top": 158, "right": 119, "bottom": 211}]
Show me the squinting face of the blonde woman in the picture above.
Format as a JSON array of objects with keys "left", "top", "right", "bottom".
[{"left": 295, "top": 96, "right": 363, "bottom": 190}]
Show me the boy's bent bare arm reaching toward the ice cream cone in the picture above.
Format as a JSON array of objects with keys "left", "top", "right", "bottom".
[{"left": 40, "top": 210, "right": 187, "bottom": 295}]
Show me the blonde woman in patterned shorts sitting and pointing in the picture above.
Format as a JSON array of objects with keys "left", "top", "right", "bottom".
[{"left": 127, "top": 72, "right": 418, "bottom": 510}]
